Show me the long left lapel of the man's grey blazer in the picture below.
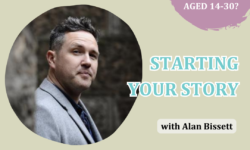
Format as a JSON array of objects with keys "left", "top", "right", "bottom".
[{"left": 40, "top": 78, "right": 95, "bottom": 143}]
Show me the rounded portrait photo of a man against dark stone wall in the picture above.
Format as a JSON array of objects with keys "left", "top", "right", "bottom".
[{"left": 5, "top": 5, "right": 142, "bottom": 145}]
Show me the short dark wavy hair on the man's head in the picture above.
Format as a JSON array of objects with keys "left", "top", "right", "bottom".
[{"left": 49, "top": 17, "right": 98, "bottom": 50}]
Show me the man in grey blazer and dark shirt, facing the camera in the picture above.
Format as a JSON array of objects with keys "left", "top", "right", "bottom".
[{"left": 35, "top": 17, "right": 102, "bottom": 145}]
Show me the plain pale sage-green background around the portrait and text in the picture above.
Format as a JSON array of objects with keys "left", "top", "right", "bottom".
[{"left": 0, "top": 0, "right": 250, "bottom": 150}]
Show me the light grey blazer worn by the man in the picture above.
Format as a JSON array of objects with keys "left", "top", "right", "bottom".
[{"left": 35, "top": 79, "right": 102, "bottom": 145}]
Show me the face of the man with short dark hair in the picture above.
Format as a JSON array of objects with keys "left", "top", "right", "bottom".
[{"left": 55, "top": 31, "right": 99, "bottom": 92}]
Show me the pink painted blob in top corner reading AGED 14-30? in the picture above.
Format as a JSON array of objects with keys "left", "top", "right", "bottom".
[{"left": 171, "top": 0, "right": 250, "bottom": 31}]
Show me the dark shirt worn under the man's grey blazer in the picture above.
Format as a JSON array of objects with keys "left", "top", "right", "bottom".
[{"left": 54, "top": 84, "right": 95, "bottom": 140}]
